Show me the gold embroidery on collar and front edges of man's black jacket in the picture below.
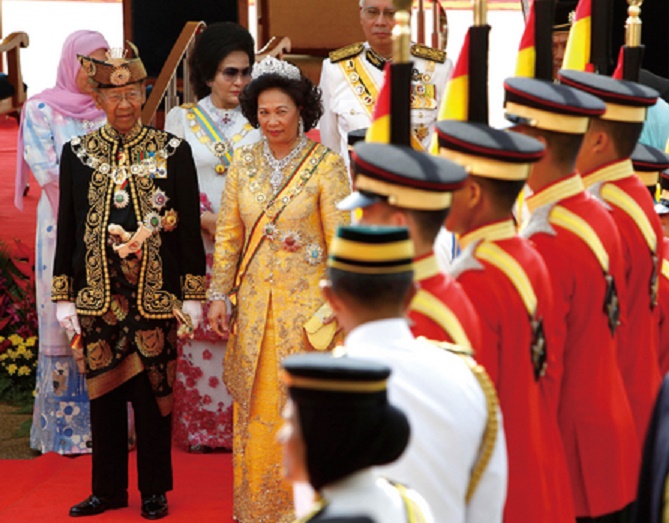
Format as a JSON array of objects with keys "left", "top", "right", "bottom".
[{"left": 70, "top": 125, "right": 181, "bottom": 319}]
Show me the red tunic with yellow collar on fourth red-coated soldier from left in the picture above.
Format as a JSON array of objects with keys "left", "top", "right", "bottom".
[{"left": 581, "top": 159, "right": 662, "bottom": 442}]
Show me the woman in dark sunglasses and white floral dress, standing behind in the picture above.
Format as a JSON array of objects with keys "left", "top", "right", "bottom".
[{"left": 165, "top": 22, "right": 260, "bottom": 452}]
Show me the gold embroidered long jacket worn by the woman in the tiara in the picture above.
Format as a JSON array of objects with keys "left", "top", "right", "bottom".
[{"left": 209, "top": 141, "right": 351, "bottom": 408}]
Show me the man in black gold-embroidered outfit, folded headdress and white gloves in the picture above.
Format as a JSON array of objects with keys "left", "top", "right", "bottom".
[{"left": 51, "top": 46, "right": 206, "bottom": 519}]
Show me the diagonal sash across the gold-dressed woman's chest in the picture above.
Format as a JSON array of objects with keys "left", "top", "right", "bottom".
[{"left": 229, "top": 143, "right": 327, "bottom": 305}]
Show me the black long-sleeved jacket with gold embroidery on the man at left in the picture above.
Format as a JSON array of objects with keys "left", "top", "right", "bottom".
[{"left": 51, "top": 125, "right": 205, "bottom": 319}]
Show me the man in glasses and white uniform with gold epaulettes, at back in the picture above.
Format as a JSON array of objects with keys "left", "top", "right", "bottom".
[{"left": 320, "top": 0, "right": 452, "bottom": 162}]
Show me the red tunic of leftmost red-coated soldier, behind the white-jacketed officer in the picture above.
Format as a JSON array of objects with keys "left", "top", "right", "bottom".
[{"left": 409, "top": 253, "right": 481, "bottom": 350}]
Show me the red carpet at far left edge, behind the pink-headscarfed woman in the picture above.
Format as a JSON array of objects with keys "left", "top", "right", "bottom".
[{"left": 0, "top": 116, "right": 41, "bottom": 255}]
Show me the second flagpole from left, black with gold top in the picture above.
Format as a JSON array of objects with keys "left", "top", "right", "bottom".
[{"left": 467, "top": 0, "right": 490, "bottom": 124}]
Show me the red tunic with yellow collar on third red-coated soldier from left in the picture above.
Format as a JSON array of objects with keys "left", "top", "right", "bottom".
[{"left": 521, "top": 174, "right": 640, "bottom": 517}]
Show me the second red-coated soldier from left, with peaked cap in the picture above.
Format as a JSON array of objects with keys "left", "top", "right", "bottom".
[{"left": 437, "top": 121, "right": 574, "bottom": 523}]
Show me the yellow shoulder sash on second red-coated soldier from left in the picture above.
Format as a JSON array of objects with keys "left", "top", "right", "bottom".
[{"left": 476, "top": 241, "right": 547, "bottom": 380}]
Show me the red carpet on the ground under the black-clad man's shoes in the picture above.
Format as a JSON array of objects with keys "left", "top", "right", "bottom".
[{"left": 0, "top": 448, "right": 233, "bottom": 523}]
